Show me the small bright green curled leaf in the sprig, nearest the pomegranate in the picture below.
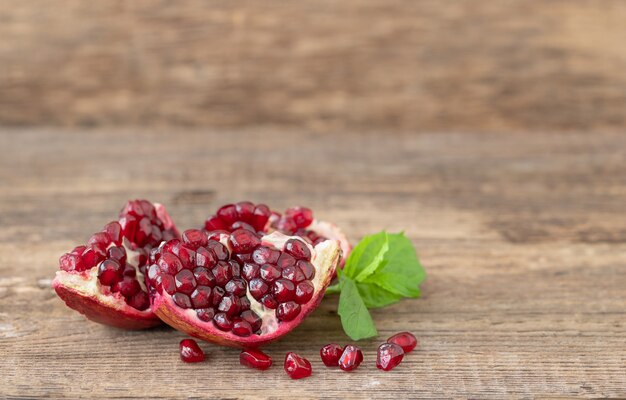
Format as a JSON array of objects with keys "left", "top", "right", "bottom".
[{"left": 343, "top": 231, "right": 389, "bottom": 282}]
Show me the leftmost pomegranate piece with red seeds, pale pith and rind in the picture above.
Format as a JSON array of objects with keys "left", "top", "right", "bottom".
[{"left": 52, "top": 200, "right": 178, "bottom": 329}]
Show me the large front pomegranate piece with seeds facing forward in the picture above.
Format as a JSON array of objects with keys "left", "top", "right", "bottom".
[{"left": 147, "top": 228, "right": 341, "bottom": 348}]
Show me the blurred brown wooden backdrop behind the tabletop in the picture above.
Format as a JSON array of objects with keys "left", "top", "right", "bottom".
[{"left": 0, "top": 0, "right": 626, "bottom": 132}]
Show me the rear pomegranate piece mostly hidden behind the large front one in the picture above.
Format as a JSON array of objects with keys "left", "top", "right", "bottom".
[{"left": 204, "top": 201, "right": 352, "bottom": 265}]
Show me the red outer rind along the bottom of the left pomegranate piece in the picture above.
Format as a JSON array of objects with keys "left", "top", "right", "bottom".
[{"left": 52, "top": 279, "right": 162, "bottom": 330}]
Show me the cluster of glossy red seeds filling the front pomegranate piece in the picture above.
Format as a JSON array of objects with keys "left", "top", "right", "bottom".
[{"left": 148, "top": 228, "right": 315, "bottom": 337}]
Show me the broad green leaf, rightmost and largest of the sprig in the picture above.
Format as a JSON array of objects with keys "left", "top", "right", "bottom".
[{"left": 364, "top": 233, "right": 426, "bottom": 297}]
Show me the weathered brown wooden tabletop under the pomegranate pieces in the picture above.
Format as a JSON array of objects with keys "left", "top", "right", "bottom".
[{"left": 0, "top": 128, "right": 626, "bottom": 399}]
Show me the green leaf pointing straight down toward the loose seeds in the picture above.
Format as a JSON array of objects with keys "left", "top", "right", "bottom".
[{"left": 337, "top": 274, "right": 378, "bottom": 340}]
